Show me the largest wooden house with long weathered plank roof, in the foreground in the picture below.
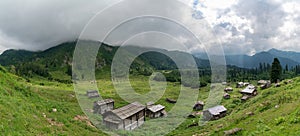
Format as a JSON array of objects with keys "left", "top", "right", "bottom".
[{"left": 103, "top": 102, "right": 146, "bottom": 130}]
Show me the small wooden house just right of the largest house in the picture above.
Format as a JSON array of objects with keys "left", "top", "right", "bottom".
[{"left": 146, "top": 104, "right": 167, "bottom": 118}]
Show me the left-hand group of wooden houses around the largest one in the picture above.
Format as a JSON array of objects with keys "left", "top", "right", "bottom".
[{"left": 86, "top": 91, "right": 167, "bottom": 130}]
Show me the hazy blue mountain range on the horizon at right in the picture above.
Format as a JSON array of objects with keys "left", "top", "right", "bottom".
[{"left": 194, "top": 49, "right": 300, "bottom": 68}]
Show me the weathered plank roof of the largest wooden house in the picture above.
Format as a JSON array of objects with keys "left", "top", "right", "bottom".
[{"left": 105, "top": 102, "right": 145, "bottom": 120}]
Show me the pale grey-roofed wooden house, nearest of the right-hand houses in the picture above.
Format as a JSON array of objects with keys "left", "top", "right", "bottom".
[{"left": 203, "top": 105, "right": 227, "bottom": 121}]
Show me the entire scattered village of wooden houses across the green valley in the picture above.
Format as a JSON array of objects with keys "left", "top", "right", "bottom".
[{"left": 87, "top": 80, "right": 292, "bottom": 127}]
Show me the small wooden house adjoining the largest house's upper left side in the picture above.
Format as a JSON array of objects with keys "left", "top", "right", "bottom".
[{"left": 93, "top": 99, "right": 114, "bottom": 114}]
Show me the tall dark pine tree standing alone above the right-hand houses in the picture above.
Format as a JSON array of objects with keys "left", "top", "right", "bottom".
[{"left": 270, "top": 58, "right": 282, "bottom": 83}]
